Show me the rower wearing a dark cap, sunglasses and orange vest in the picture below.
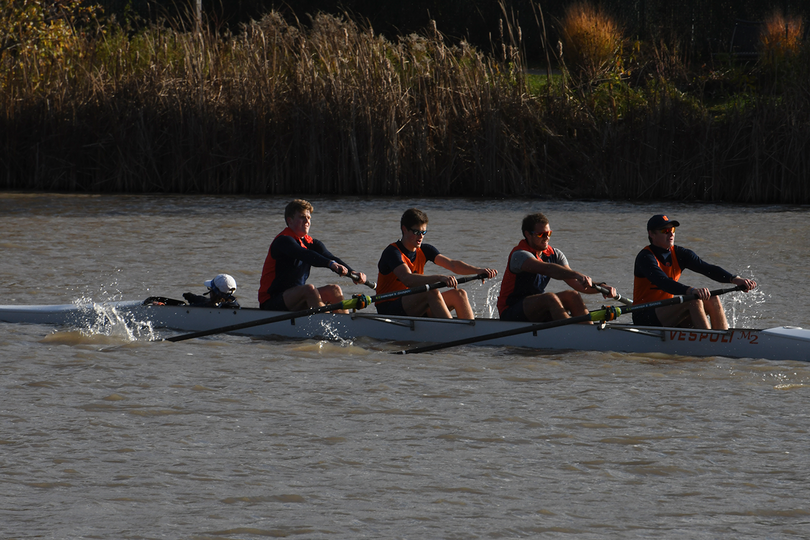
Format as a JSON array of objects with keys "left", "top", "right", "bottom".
[{"left": 632, "top": 214, "right": 757, "bottom": 330}]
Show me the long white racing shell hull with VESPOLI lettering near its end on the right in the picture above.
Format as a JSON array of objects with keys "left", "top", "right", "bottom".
[{"left": 0, "top": 301, "right": 810, "bottom": 361}]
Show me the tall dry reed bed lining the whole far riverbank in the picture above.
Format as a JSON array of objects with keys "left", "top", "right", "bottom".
[{"left": 0, "top": 6, "right": 810, "bottom": 203}]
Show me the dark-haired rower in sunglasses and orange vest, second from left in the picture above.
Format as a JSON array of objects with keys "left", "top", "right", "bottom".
[{"left": 376, "top": 208, "right": 498, "bottom": 319}]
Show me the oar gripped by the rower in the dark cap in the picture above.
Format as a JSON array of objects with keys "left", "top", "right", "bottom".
[{"left": 399, "top": 285, "right": 742, "bottom": 354}]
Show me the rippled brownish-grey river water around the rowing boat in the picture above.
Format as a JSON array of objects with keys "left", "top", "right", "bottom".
[{"left": 0, "top": 193, "right": 810, "bottom": 539}]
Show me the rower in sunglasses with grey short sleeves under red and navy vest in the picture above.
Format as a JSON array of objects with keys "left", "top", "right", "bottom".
[{"left": 498, "top": 213, "right": 616, "bottom": 322}]
